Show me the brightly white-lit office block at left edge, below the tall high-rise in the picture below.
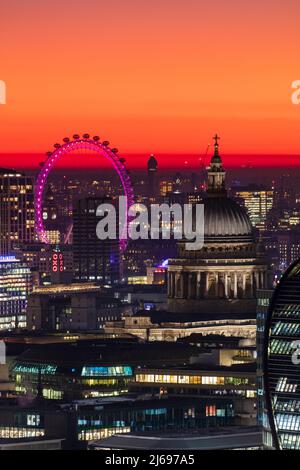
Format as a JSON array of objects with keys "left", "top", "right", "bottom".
[{"left": 0, "top": 256, "right": 32, "bottom": 330}]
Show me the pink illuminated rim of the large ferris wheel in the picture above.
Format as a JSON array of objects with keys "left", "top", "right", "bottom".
[{"left": 34, "top": 134, "right": 134, "bottom": 251}]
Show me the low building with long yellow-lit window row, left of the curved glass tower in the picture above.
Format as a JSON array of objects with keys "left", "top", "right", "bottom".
[{"left": 130, "top": 363, "right": 257, "bottom": 426}]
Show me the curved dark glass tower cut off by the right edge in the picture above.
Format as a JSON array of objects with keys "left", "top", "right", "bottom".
[{"left": 263, "top": 259, "right": 300, "bottom": 449}]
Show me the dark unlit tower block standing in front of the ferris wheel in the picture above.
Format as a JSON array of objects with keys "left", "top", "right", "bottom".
[{"left": 73, "top": 197, "right": 120, "bottom": 284}]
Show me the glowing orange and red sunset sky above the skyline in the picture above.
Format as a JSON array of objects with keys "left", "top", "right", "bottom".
[{"left": 0, "top": 0, "right": 300, "bottom": 167}]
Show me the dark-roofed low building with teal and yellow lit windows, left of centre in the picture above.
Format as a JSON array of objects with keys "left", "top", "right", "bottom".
[{"left": 12, "top": 338, "right": 196, "bottom": 401}]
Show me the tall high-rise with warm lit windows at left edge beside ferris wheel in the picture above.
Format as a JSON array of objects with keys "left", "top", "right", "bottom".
[{"left": 0, "top": 169, "right": 34, "bottom": 255}]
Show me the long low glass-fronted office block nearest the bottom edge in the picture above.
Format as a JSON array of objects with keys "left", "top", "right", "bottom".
[{"left": 0, "top": 397, "right": 235, "bottom": 449}]
